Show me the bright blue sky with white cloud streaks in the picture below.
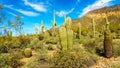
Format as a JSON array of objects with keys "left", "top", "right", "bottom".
[{"left": 0, "top": 0, "right": 120, "bottom": 33}]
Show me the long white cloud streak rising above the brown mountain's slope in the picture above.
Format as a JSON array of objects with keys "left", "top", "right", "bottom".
[{"left": 79, "top": 0, "right": 112, "bottom": 17}]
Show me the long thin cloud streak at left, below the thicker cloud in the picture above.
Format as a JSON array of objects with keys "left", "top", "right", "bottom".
[{"left": 5, "top": 5, "right": 39, "bottom": 16}]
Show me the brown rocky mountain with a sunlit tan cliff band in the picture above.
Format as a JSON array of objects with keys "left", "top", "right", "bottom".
[{"left": 72, "top": 5, "right": 120, "bottom": 31}]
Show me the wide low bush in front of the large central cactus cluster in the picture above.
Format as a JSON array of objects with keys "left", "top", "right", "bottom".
[{"left": 50, "top": 49, "right": 97, "bottom": 68}]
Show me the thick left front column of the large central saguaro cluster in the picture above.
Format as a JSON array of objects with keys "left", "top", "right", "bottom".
[{"left": 59, "top": 27, "right": 67, "bottom": 51}]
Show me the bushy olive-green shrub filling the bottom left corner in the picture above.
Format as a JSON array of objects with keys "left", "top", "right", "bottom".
[{"left": 0, "top": 53, "right": 22, "bottom": 68}]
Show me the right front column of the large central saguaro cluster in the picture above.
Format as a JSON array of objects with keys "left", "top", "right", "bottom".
[{"left": 67, "top": 29, "right": 73, "bottom": 50}]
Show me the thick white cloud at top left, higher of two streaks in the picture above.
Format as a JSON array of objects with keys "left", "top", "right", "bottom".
[{"left": 23, "top": 0, "right": 47, "bottom": 12}]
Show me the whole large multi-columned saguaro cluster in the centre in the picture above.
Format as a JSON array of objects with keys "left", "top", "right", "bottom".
[{"left": 59, "top": 17, "right": 73, "bottom": 51}]
